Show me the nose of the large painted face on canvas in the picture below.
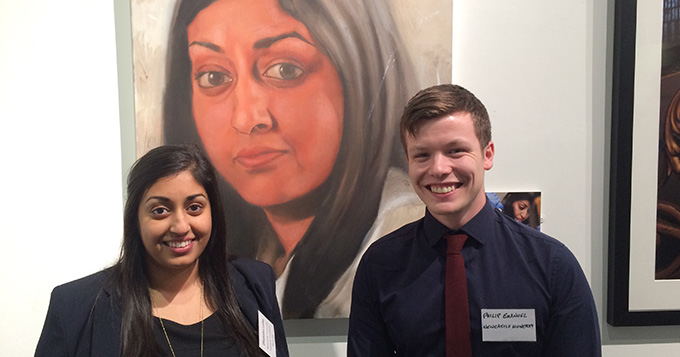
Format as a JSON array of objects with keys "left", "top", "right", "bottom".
[{"left": 231, "top": 81, "right": 276, "bottom": 135}]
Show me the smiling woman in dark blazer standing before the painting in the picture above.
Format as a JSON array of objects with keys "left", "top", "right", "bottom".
[{"left": 36, "top": 146, "right": 288, "bottom": 357}]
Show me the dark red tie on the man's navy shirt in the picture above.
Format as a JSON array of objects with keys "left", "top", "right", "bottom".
[{"left": 444, "top": 234, "right": 472, "bottom": 357}]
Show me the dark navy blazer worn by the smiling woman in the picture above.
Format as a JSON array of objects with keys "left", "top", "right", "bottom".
[{"left": 35, "top": 258, "right": 288, "bottom": 357}]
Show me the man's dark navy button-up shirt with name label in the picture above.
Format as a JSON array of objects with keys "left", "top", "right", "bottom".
[{"left": 347, "top": 202, "right": 601, "bottom": 356}]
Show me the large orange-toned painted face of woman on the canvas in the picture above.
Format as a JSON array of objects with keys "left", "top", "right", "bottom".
[{"left": 187, "top": 0, "right": 343, "bottom": 207}]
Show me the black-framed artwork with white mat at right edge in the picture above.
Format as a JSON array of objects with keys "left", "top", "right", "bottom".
[{"left": 607, "top": 0, "right": 680, "bottom": 326}]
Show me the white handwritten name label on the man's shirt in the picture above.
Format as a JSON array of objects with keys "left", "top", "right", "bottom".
[{"left": 482, "top": 309, "right": 536, "bottom": 342}]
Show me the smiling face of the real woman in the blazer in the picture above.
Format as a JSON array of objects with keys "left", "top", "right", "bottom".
[{"left": 138, "top": 171, "right": 212, "bottom": 269}]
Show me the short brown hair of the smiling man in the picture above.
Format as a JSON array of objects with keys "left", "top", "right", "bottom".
[{"left": 400, "top": 84, "right": 491, "bottom": 154}]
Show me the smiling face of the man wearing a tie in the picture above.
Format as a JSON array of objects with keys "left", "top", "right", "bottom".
[{"left": 406, "top": 112, "right": 494, "bottom": 229}]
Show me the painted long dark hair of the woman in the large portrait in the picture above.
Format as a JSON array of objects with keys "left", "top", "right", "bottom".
[{"left": 163, "top": 0, "right": 415, "bottom": 318}]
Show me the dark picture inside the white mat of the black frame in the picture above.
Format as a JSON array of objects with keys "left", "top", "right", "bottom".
[{"left": 655, "top": 1, "right": 680, "bottom": 280}]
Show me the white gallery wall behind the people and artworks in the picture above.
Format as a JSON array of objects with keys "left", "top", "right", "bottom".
[{"left": 0, "top": 0, "right": 680, "bottom": 356}]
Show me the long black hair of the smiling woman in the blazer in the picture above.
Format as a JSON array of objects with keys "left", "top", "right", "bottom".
[{"left": 111, "top": 145, "right": 259, "bottom": 357}]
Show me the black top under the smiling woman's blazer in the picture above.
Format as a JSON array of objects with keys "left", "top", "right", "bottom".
[{"left": 154, "top": 314, "right": 244, "bottom": 357}]
